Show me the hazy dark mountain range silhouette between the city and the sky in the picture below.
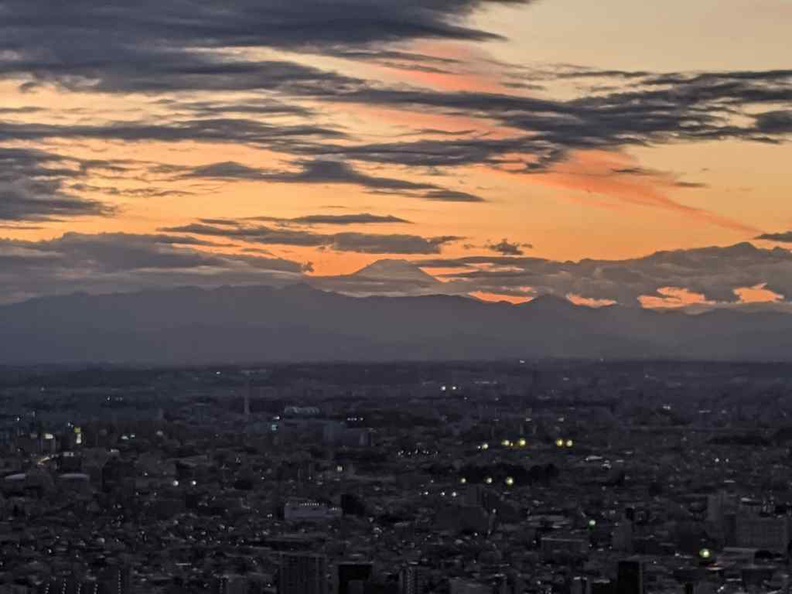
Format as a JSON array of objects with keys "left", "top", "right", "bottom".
[{"left": 0, "top": 284, "right": 792, "bottom": 364}]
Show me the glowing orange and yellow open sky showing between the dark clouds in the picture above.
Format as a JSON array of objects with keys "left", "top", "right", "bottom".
[{"left": 0, "top": 0, "right": 792, "bottom": 306}]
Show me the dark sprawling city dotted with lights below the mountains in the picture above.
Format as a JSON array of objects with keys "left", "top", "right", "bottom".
[{"left": 0, "top": 361, "right": 792, "bottom": 594}]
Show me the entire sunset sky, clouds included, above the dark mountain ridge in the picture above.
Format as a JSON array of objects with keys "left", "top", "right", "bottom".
[{"left": 0, "top": 0, "right": 792, "bottom": 307}]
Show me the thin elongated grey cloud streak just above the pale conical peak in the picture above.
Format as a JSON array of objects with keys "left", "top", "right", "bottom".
[{"left": 162, "top": 222, "right": 461, "bottom": 254}]
